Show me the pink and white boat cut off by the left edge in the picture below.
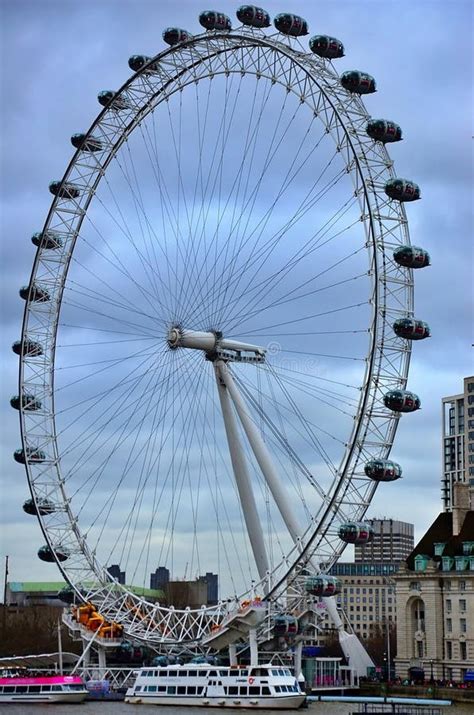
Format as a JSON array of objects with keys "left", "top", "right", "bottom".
[{"left": 0, "top": 675, "right": 88, "bottom": 703}]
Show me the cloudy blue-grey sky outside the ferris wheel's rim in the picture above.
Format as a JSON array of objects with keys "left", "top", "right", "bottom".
[{"left": 0, "top": 0, "right": 473, "bottom": 592}]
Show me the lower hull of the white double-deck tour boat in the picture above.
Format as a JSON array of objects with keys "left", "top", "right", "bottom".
[{"left": 125, "top": 694, "right": 306, "bottom": 710}]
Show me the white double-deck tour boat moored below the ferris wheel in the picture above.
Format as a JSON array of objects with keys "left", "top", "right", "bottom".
[{"left": 125, "top": 663, "right": 306, "bottom": 710}]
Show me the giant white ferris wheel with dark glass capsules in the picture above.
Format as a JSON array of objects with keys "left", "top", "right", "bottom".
[{"left": 12, "top": 5, "right": 429, "bottom": 656}]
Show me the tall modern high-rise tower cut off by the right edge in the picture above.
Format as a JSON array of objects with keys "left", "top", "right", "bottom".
[{"left": 441, "top": 376, "right": 474, "bottom": 511}]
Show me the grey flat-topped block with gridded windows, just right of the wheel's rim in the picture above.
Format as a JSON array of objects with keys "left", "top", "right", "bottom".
[{"left": 354, "top": 519, "right": 415, "bottom": 564}]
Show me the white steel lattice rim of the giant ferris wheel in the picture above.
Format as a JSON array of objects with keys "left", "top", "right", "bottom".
[{"left": 19, "top": 22, "right": 413, "bottom": 646}]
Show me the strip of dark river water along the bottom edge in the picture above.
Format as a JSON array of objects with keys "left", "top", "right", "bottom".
[{"left": 0, "top": 702, "right": 474, "bottom": 715}]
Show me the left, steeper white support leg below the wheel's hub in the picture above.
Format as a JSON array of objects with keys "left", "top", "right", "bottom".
[{"left": 214, "top": 360, "right": 269, "bottom": 579}]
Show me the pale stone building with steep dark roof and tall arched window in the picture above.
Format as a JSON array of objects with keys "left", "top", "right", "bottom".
[{"left": 394, "top": 482, "right": 474, "bottom": 681}]
